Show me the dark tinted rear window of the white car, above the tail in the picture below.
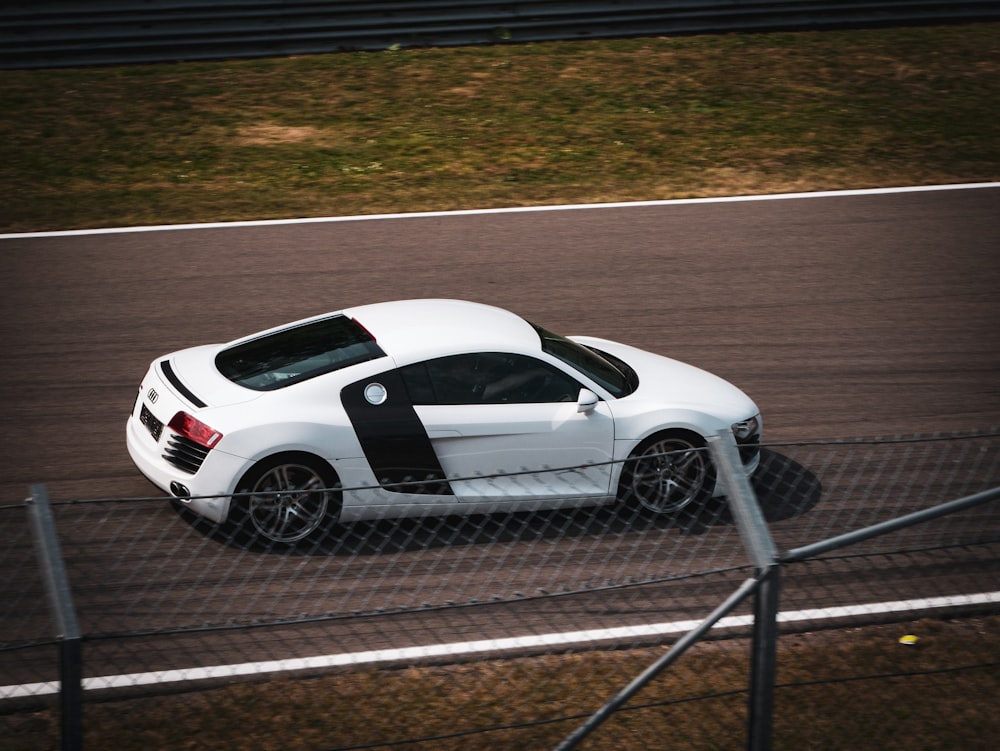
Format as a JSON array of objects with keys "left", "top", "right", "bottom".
[{"left": 215, "top": 315, "right": 385, "bottom": 391}]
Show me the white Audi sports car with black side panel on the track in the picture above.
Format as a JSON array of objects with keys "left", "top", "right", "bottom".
[{"left": 126, "top": 300, "right": 761, "bottom": 543}]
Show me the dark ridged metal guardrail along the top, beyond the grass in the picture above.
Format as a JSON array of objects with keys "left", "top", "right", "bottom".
[{"left": 0, "top": 0, "right": 1000, "bottom": 69}]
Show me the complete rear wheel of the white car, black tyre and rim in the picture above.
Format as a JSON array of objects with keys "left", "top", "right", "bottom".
[{"left": 237, "top": 454, "right": 341, "bottom": 545}]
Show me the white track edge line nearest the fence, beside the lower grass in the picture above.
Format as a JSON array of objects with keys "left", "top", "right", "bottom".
[{"left": 0, "top": 592, "right": 1000, "bottom": 701}]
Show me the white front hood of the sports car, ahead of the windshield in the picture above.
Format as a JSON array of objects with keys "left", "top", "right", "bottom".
[{"left": 572, "top": 336, "right": 758, "bottom": 419}]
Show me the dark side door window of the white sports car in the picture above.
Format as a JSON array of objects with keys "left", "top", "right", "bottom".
[{"left": 401, "top": 352, "right": 580, "bottom": 404}]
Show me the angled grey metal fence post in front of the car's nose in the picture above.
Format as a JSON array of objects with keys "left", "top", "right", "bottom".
[{"left": 708, "top": 430, "right": 781, "bottom": 751}]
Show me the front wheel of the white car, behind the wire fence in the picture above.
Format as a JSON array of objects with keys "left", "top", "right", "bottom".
[{"left": 625, "top": 436, "right": 715, "bottom": 514}]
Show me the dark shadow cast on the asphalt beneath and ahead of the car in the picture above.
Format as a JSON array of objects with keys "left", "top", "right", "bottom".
[{"left": 175, "top": 449, "right": 822, "bottom": 556}]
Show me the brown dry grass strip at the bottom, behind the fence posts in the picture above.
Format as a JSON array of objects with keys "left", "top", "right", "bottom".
[{"left": 7, "top": 616, "right": 1000, "bottom": 751}]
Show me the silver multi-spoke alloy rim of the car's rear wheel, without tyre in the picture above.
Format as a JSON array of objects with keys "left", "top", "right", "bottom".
[{"left": 247, "top": 463, "right": 334, "bottom": 543}]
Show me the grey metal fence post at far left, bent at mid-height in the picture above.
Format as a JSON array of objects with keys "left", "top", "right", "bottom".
[{"left": 26, "top": 485, "right": 83, "bottom": 751}]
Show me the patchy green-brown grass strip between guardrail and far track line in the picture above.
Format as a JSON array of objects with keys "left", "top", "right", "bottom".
[{"left": 0, "top": 24, "right": 1000, "bottom": 231}]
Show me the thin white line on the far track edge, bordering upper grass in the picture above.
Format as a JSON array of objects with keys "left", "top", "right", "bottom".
[{"left": 0, "top": 182, "right": 1000, "bottom": 240}]
